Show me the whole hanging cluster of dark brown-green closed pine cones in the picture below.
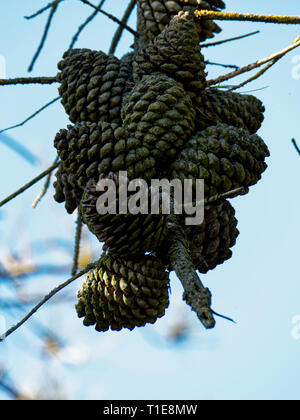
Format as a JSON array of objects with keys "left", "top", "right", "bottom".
[{"left": 54, "top": 0, "right": 269, "bottom": 331}]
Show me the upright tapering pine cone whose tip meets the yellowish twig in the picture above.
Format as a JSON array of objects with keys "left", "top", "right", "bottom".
[{"left": 134, "top": 12, "right": 206, "bottom": 102}]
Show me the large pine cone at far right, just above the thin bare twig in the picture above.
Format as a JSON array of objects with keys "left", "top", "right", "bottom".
[{"left": 171, "top": 124, "right": 270, "bottom": 197}]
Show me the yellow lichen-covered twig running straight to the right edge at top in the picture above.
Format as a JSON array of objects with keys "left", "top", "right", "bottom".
[{"left": 195, "top": 10, "right": 300, "bottom": 25}]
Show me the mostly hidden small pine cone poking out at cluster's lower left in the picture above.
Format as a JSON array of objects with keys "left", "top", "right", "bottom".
[{"left": 53, "top": 163, "right": 82, "bottom": 214}]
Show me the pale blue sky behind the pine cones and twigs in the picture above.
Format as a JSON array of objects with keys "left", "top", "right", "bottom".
[{"left": 0, "top": 0, "right": 300, "bottom": 400}]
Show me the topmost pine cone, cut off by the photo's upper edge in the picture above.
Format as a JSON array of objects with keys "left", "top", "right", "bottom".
[{"left": 138, "top": 0, "right": 225, "bottom": 43}]
